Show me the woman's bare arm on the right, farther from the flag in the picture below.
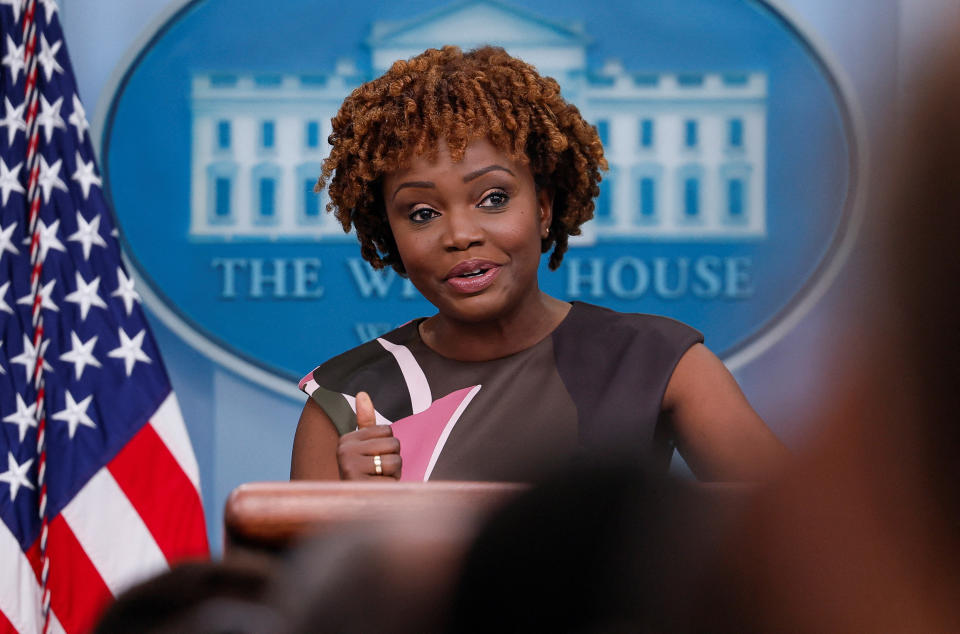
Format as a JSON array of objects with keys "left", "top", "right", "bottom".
[{"left": 662, "top": 344, "right": 790, "bottom": 481}]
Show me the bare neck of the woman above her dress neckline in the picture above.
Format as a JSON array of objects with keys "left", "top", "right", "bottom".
[{"left": 420, "top": 292, "right": 571, "bottom": 361}]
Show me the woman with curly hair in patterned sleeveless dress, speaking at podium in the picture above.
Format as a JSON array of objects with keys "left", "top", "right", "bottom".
[{"left": 291, "top": 47, "right": 786, "bottom": 480}]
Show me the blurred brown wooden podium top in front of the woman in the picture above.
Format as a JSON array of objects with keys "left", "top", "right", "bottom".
[{"left": 224, "top": 481, "right": 527, "bottom": 558}]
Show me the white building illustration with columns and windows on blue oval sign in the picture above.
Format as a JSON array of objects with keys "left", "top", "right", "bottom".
[{"left": 190, "top": 0, "right": 767, "bottom": 245}]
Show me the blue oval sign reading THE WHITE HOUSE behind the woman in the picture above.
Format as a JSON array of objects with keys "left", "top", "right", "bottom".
[{"left": 101, "top": 0, "right": 863, "bottom": 388}]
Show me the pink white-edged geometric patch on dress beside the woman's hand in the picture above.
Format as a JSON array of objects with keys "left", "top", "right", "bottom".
[{"left": 391, "top": 385, "right": 480, "bottom": 482}]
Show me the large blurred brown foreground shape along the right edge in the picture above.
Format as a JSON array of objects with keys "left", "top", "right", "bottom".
[{"left": 710, "top": 25, "right": 960, "bottom": 632}]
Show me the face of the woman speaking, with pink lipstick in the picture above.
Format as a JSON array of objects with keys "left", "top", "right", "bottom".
[{"left": 383, "top": 139, "right": 551, "bottom": 322}]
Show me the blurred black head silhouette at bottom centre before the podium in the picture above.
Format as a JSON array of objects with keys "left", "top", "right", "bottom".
[{"left": 446, "top": 462, "right": 743, "bottom": 633}]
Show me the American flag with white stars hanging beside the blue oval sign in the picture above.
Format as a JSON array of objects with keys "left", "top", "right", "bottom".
[{"left": 0, "top": 0, "right": 208, "bottom": 633}]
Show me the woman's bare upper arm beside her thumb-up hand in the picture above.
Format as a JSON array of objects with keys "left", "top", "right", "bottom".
[{"left": 290, "top": 399, "right": 340, "bottom": 480}]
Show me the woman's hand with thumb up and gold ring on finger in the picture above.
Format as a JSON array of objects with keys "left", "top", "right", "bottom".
[{"left": 337, "top": 392, "right": 403, "bottom": 480}]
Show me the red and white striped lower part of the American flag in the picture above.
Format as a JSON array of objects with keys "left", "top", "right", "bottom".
[{"left": 0, "top": 393, "right": 209, "bottom": 634}]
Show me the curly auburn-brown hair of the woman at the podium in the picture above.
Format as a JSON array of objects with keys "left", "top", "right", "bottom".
[{"left": 315, "top": 46, "right": 607, "bottom": 274}]
